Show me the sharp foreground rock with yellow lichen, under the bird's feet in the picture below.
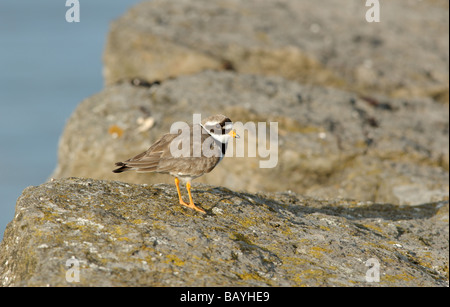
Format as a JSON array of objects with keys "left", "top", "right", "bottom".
[{"left": 0, "top": 178, "right": 449, "bottom": 286}]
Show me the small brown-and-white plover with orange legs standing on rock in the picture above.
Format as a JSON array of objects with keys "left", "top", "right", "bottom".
[{"left": 113, "top": 114, "right": 239, "bottom": 213}]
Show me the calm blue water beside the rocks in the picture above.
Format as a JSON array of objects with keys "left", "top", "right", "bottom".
[{"left": 0, "top": 0, "right": 140, "bottom": 238}]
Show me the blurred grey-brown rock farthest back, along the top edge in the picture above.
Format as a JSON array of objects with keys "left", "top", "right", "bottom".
[{"left": 104, "top": 0, "right": 449, "bottom": 103}]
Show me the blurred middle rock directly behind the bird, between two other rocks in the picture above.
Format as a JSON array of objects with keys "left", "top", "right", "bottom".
[{"left": 53, "top": 71, "right": 449, "bottom": 204}]
